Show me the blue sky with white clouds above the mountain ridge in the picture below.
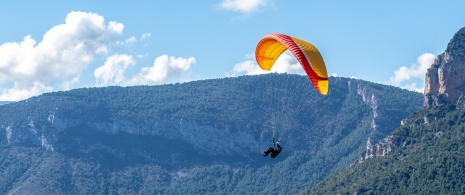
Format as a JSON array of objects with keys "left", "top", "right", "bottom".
[{"left": 0, "top": 0, "right": 465, "bottom": 101}]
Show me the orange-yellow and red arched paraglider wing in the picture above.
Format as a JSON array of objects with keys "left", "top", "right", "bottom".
[{"left": 255, "top": 33, "right": 328, "bottom": 95}]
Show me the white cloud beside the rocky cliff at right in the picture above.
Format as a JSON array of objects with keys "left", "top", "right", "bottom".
[{"left": 387, "top": 53, "right": 436, "bottom": 92}]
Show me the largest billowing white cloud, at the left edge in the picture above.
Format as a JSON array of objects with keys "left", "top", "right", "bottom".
[{"left": 0, "top": 12, "right": 124, "bottom": 100}]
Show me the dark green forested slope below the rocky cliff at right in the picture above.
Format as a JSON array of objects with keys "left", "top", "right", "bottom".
[{"left": 305, "top": 103, "right": 465, "bottom": 194}]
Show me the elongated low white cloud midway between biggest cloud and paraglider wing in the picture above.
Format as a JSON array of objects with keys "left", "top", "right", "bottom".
[{"left": 126, "top": 55, "right": 196, "bottom": 85}]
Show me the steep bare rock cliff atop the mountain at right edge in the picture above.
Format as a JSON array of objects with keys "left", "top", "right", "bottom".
[{"left": 424, "top": 27, "right": 465, "bottom": 108}]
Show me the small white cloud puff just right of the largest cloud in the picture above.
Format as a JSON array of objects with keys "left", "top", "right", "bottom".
[{"left": 94, "top": 55, "right": 136, "bottom": 85}]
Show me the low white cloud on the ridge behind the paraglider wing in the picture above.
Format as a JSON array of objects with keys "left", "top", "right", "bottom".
[{"left": 226, "top": 51, "right": 305, "bottom": 77}]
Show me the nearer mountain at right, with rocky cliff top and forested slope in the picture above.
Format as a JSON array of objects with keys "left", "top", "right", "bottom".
[{"left": 304, "top": 28, "right": 465, "bottom": 194}]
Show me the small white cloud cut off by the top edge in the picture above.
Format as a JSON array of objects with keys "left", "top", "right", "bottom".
[{"left": 220, "top": 0, "right": 270, "bottom": 14}]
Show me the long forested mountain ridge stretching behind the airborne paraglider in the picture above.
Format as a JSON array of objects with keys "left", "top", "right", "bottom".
[{"left": 0, "top": 74, "right": 423, "bottom": 194}]
